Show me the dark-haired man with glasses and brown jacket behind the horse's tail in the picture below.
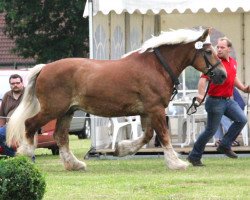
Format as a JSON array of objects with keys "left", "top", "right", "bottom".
[{"left": 0, "top": 74, "right": 24, "bottom": 157}]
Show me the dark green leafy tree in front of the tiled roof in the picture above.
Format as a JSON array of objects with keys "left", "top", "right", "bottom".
[{"left": 0, "top": 0, "right": 88, "bottom": 63}]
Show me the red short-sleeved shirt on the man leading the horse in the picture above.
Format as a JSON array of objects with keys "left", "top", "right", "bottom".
[{"left": 201, "top": 57, "right": 237, "bottom": 97}]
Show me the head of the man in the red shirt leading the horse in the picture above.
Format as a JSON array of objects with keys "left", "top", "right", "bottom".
[{"left": 217, "top": 37, "right": 232, "bottom": 60}]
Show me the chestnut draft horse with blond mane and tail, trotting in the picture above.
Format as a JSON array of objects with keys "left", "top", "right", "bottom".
[{"left": 7, "top": 29, "right": 227, "bottom": 170}]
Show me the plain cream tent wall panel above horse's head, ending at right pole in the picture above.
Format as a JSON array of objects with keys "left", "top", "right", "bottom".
[{"left": 160, "top": 13, "right": 245, "bottom": 81}]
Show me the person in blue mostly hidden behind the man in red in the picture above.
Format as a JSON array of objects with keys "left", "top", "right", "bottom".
[{"left": 214, "top": 88, "right": 246, "bottom": 146}]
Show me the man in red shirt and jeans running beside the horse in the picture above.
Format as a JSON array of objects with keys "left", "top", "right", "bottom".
[{"left": 187, "top": 37, "right": 250, "bottom": 166}]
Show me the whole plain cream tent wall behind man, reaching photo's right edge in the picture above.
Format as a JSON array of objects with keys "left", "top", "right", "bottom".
[{"left": 159, "top": 13, "right": 250, "bottom": 120}]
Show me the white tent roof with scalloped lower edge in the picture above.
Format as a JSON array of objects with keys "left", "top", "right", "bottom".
[{"left": 83, "top": 0, "right": 250, "bottom": 17}]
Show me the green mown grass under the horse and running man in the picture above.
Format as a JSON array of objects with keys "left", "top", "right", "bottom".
[{"left": 36, "top": 136, "right": 250, "bottom": 200}]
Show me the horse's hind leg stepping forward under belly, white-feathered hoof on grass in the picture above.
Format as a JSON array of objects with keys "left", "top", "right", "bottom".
[{"left": 54, "top": 114, "right": 86, "bottom": 170}]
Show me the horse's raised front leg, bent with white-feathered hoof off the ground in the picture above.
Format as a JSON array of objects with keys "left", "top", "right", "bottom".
[{"left": 114, "top": 116, "right": 153, "bottom": 156}]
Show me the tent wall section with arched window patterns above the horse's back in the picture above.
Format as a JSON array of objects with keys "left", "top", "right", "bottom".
[{"left": 93, "top": 12, "right": 155, "bottom": 59}]
